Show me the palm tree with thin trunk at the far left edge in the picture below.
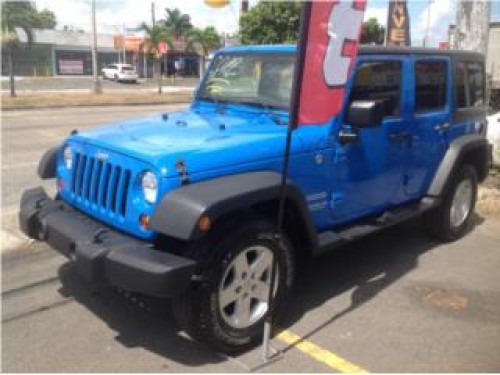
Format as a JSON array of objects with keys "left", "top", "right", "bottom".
[{"left": 1, "top": 2, "right": 39, "bottom": 97}]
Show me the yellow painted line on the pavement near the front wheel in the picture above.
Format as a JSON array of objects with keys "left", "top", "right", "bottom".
[{"left": 276, "top": 330, "right": 368, "bottom": 373}]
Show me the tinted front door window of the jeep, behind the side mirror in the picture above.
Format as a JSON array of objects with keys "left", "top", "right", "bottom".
[{"left": 349, "top": 61, "right": 402, "bottom": 117}]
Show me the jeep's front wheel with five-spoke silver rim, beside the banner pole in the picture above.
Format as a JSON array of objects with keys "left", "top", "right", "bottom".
[{"left": 173, "top": 219, "right": 294, "bottom": 353}]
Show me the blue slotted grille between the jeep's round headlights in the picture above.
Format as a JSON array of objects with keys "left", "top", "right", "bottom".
[{"left": 71, "top": 153, "right": 132, "bottom": 216}]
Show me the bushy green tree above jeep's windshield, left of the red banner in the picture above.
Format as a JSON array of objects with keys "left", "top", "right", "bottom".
[{"left": 240, "top": 1, "right": 302, "bottom": 44}]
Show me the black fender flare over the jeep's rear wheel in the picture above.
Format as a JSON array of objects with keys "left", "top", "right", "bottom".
[{"left": 427, "top": 134, "right": 489, "bottom": 197}]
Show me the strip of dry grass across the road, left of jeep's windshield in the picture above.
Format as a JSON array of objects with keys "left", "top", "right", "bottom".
[{"left": 2, "top": 92, "right": 193, "bottom": 109}]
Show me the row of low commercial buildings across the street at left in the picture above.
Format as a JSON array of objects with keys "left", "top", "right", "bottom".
[{"left": 2, "top": 30, "right": 201, "bottom": 78}]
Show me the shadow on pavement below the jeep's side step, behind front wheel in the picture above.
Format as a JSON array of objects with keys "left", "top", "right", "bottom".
[{"left": 280, "top": 214, "right": 485, "bottom": 352}]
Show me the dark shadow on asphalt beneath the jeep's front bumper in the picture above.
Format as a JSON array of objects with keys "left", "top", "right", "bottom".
[{"left": 59, "top": 263, "right": 225, "bottom": 367}]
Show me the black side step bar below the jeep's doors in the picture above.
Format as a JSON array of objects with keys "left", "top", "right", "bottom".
[{"left": 313, "top": 197, "right": 439, "bottom": 255}]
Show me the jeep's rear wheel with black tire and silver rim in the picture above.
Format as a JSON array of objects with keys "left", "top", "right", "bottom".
[{"left": 424, "top": 164, "right": 477, "bottom": 241}]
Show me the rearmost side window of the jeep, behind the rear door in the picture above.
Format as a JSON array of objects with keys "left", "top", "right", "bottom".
[{"left": 455, "top": 62, "right": 484, "bottom": 109}]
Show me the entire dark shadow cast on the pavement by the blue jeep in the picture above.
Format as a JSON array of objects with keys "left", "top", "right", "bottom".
[{"left": 55, "top": 215, "right": 484, "bottom": 367}]
